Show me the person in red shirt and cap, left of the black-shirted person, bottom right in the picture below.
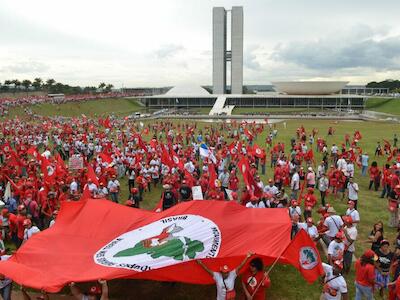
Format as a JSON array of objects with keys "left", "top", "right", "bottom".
[{"left": 354, "top": 249, "right": 378, "bottom": 300}]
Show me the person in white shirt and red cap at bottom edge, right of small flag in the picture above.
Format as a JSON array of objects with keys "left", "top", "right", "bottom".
[{"left": 320, "top": 260, "right": 349, "bottom": 300}]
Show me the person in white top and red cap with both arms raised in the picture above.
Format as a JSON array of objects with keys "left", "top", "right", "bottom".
[{"left": 196, "top": 252, "right": 253, "bottom": 300}]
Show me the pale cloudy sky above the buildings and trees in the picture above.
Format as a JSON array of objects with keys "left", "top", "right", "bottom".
[{"left": 0, "top": 0, "right": 400, "bottom": 87}]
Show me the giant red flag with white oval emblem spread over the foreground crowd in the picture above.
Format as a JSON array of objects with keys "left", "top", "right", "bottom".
[{"left": 0, "top": 199, "right": 298, "bottom": 292}]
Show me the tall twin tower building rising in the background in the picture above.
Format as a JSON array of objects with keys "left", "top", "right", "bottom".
[{"left": 213, "top": 6, "right": 243, "bottom": 94}]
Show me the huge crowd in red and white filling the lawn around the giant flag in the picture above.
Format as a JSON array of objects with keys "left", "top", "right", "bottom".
[{"left": 0, "top": 113, "right": 400, "bottom": 299}]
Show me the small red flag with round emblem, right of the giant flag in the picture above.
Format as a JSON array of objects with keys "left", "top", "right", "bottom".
[{"left": 282, "top": 229, "right": 324, "bottom": 283}]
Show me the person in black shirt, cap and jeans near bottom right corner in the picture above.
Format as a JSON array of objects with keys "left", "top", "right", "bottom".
[{"left": 375, "top": 240, "right": 394, "bottom": 297}]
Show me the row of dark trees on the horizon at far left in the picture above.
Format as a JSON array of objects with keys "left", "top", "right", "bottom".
[{"left": 0, "top": 78, "right": 114, "bottom": 95}]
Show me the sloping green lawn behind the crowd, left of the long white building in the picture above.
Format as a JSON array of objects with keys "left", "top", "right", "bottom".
[{"left": 10, "top": 98, "right": 145, "bottom": 117}]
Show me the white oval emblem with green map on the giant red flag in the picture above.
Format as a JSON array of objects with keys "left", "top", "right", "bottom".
[{"left": 94, "top": 215, "right": 221, "bottom": 271}]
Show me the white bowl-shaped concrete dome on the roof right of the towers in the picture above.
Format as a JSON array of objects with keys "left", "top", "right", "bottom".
[{"left": 272, "top": 81, "right": 349, "bottom": 95}]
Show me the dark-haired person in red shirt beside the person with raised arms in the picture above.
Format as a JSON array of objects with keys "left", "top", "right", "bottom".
[{"left": 242, "top": 257, "right": 271, "bottom": 300}]
